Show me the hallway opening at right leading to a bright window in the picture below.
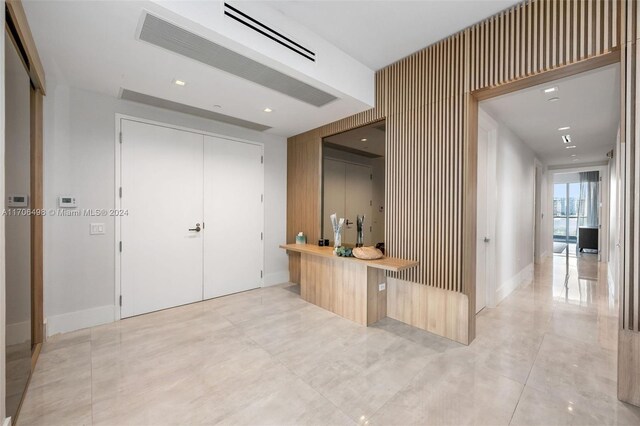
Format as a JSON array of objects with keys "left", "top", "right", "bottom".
[{"left": 475, "top": 63, "right": 620, "bottom": 318}]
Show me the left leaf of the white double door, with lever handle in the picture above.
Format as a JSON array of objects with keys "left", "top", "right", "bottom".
[{"left": 121, "top": 119, "right": 203, "bottom": 318}]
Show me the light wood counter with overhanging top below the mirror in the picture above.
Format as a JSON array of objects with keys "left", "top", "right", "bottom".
[{"left": 280, "top": 244, "right": 418, "bottom": 325}]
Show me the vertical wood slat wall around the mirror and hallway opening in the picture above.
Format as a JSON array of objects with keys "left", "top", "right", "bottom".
[{"left": 288, "top": 0, "right": 640, "bottom": 341}]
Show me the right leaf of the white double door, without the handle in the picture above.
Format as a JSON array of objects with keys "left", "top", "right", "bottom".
[{"left": 204, "top": 136, "right": 264, "bottom": 299}]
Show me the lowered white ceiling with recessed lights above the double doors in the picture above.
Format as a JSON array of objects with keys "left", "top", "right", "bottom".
[{"left": 24, "top": 0, "right": 368, "bottom": 136}]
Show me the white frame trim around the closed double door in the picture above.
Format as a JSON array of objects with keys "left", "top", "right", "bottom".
[{"left": 114, "top": 113, "right": 264, "bottom": 320}]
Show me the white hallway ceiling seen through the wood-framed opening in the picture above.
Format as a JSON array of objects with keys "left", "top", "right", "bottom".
[{"left": 480, "top": 64, "right": 620, "bottom": 166}]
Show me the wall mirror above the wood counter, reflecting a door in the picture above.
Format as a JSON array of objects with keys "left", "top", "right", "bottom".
[{"left": 321, "top": 121, "right": 386, "bottom": 251}]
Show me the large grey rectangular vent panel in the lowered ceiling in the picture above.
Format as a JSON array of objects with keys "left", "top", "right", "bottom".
[{"left": 135, "top": 13, "right": 337, "bottom": 107}]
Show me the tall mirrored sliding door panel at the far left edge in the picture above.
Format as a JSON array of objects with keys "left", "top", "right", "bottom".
[{"left": 4, "top": 33, "right": 31, "bottom": 419}]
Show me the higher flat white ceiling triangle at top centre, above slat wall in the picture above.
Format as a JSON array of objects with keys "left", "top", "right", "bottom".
[{"left": 260, "top": 0, "right": 520, "bottom": 70}]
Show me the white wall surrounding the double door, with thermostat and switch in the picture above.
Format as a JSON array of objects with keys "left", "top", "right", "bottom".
[{"left": 44, "top": 85, "right": 289, "bottom": 335}]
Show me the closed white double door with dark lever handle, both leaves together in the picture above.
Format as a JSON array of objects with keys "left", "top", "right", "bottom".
[{"left": 120, "top": 119, "right": 264, "bottom": 318}]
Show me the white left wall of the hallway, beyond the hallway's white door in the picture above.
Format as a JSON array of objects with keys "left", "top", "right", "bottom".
[{"left": 484, "top": 111, "right": 545, "bottom": 304}]
